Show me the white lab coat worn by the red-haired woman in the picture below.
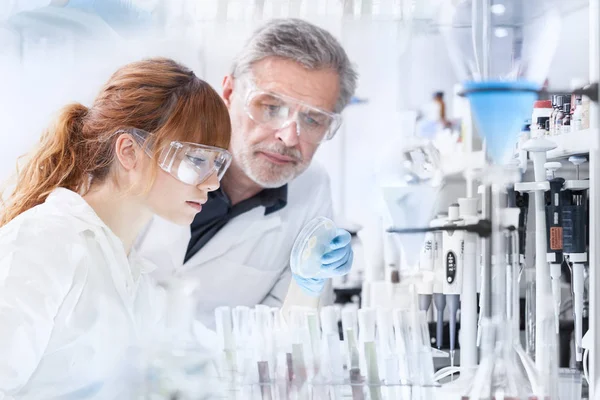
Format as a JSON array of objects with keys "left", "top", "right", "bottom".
[{"left": 0, "top": 188, "right": 165, "bottom": 400}]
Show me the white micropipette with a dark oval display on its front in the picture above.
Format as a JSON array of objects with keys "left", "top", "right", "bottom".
[{"left": 442, "top": 204, "right": 465, "bottom": 366}]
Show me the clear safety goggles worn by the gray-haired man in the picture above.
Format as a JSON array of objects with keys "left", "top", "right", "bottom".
[{"left": 245, "top": 81, "right": 342, "bottom": 144}]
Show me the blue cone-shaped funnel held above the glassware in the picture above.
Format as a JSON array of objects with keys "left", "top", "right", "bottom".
[{"left": 463, "top": 81, "right": 540, "bottom": 165}]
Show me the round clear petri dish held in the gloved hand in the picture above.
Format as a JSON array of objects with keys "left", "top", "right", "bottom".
[{"left": 290, "top": 217, "right": 337, "bottom": 278}]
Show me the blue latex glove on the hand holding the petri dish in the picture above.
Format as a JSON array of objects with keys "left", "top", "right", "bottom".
[{"left": 292, "top": 229, "right": 354, "bottom": 297}]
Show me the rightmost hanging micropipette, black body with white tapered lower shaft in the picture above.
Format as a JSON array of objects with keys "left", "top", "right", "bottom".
[{"left": 563, "top": 156, "right": 589, "bottom": 369}]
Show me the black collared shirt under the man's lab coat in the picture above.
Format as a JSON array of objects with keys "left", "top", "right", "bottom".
[{"left": 184, "top": 185, "right": 287, "bottom": 262}]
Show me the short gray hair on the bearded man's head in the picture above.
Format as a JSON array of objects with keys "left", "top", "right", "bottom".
[{"left": 231, "top": 18, "right": 358, "bottom": 112}]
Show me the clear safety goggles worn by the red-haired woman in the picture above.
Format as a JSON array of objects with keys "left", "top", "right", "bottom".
[{"left": 122, "top": 128, "right": 231, "bottom": 186}]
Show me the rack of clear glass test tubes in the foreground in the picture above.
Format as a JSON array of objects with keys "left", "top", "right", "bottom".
[{"left": 215, "top": 305, "right": 437, "bottom": 400}]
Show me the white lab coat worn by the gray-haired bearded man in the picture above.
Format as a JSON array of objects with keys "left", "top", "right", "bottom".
[{"left": 137, "top": 163, "right": 332, "bottom": 328}]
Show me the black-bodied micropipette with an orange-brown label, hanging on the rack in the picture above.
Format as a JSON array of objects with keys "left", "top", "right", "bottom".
[{"left": 544, "top": 162, "right": 565, "bottom": 333}]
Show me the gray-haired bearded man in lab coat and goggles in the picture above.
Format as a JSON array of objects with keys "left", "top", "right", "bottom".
[{"left": 138, "top": 19, "right": 357, "bottom": 326}]
